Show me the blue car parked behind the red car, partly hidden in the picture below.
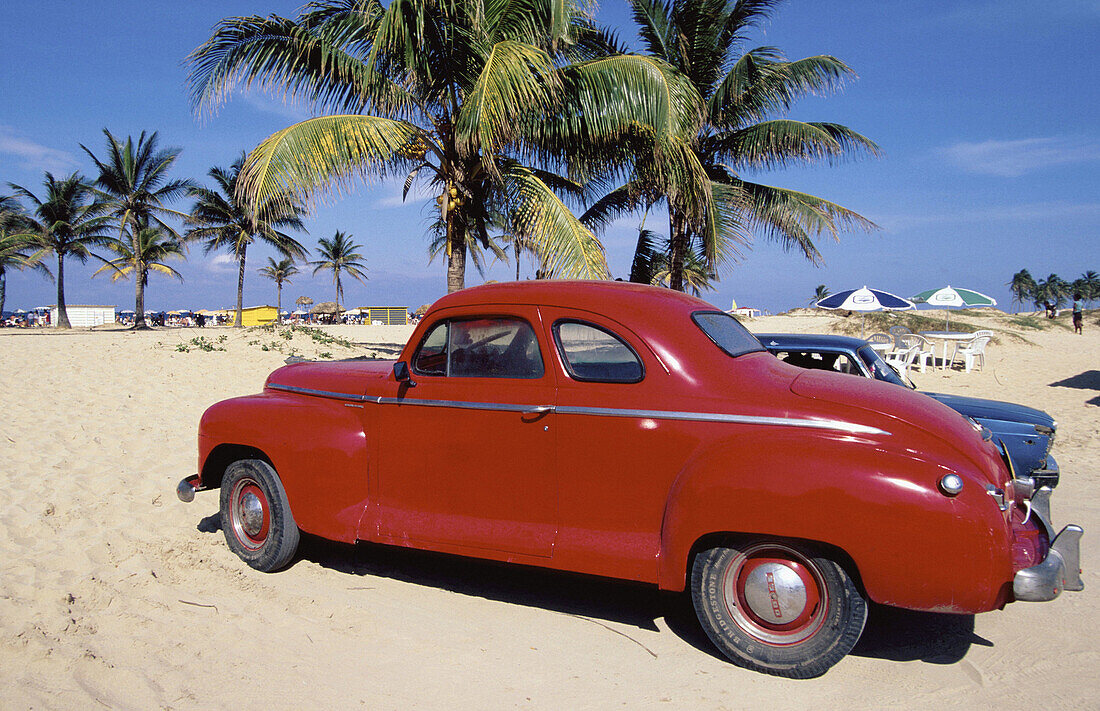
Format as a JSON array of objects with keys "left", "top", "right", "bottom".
[{"left": 756, "top": 333, "right": 1058, "bottom": 488}]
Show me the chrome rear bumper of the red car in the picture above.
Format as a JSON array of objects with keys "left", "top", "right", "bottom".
[{"left": 1012, "top": 486, "right": 1085, "bottom": 602}]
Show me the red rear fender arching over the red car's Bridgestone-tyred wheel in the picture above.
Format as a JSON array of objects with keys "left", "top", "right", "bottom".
[{"left": 658, "top": 431, "right": 1012, "bottom": 612}]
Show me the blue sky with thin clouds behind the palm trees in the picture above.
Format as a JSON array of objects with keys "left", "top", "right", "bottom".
[{"left": 0, "top": 0, "right": 1100, "bottom": 311}]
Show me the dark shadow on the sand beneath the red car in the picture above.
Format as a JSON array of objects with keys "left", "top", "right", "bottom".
[{"left": 187, "top": 532, "right": 992, "bottom": 665}]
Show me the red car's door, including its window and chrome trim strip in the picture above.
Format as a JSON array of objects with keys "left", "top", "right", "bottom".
[{"left": 377, "top": 307, "right": 558, "bottom": 557}]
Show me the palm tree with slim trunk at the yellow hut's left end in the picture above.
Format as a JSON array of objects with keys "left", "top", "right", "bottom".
[{"left": 187, "top": 153, "right": 307, "bottom": 328}]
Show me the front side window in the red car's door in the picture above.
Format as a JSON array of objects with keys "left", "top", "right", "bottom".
[{"left": 413, "top": 318, "right": 543, "bottom": 378}]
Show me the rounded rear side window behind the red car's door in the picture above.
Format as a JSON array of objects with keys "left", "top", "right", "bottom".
[{"left": 553, "top": 321, "right": 646, "bottom": 383}]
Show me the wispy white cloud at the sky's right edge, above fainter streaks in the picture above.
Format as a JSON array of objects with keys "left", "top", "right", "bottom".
[{"left": 939, "top": 138, "right": 1100, "bottom": 177}]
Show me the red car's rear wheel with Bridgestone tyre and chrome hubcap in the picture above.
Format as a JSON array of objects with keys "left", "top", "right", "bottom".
[{"left": 691, "top": 540, "right": 867, "bottom": 679}]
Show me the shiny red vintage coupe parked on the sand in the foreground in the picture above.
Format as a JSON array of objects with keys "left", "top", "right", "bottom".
[{"left": 178, "top": 282, "right": 1084, "bottom": 677}]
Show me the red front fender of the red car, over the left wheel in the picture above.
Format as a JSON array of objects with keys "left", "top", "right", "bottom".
[{"left": 199, "top": 391, "right": 369, "bottom": 543}]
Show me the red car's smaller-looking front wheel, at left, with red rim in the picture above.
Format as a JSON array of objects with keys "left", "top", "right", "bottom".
[{"left": 221, "top": 459, "right": 300, "bottom": 572}]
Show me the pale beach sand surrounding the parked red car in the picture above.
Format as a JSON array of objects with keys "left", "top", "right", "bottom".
[{"left": 0, "top": 315, "right": 1100, "bottom": 710}]
